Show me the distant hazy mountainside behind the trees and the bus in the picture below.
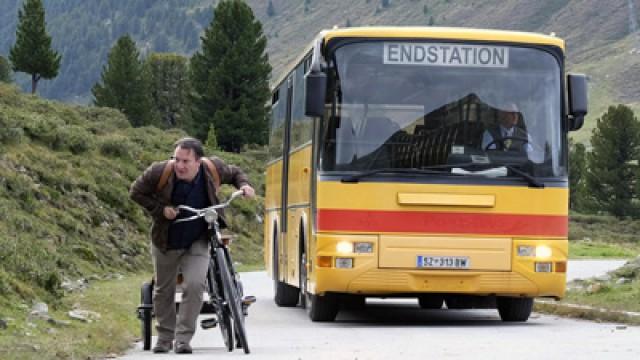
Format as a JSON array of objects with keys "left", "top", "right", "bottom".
[{"left": 0, "top": 0, "right": 640, "bottom": 140}]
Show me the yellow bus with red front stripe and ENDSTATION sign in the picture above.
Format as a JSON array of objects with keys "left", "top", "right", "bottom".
[{"left": 264, "top": 27, "right": 587, "bottom": 321}]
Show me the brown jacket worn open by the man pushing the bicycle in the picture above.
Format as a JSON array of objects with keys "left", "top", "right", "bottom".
[{"left": 129, "top": 157, "right": 249, "bottom": 250}]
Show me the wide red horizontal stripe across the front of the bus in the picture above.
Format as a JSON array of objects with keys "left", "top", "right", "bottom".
[{"left": 318, "top": 209, "right": 569, "bottom": 237}]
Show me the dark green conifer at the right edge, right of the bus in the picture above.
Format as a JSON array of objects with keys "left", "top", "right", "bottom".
[{"left": 586, "top": 105, "right": 640, "bottom": 217}]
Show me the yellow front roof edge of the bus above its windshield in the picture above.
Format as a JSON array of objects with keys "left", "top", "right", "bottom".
[{"left": 272, "top": 26, "right": 565, "bottom": 90}]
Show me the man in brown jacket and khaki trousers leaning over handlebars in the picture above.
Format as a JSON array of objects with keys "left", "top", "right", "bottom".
[{"left": 130, "top": 138, "right": 255, "bottom": 354}]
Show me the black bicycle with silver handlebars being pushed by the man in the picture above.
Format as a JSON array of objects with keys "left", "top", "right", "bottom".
[{"left": 138, "top": 190, "right": 256, "bottom": 354}]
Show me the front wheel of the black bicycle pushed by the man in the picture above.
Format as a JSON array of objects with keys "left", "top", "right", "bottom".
[{"left": 216, "top": 249, "right": 249, "bottom": 354}]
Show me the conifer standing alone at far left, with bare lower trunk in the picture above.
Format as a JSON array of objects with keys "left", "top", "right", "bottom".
[{"left": 9, "top": 0, "right": 61, "bottom": 94}]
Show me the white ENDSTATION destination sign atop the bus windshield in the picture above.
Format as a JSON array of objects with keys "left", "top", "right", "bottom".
[{"left": 384, "top": 42, "right": 509, "bottom": 68}]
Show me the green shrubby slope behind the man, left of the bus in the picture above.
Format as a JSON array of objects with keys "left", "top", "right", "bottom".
[{"left": 0, "top": 84, "right": 264, "bottom": 308}]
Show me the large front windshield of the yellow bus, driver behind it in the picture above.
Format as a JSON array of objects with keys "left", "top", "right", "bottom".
[{"left": 320, "top": 40, "right": 567, "bottom": 178}]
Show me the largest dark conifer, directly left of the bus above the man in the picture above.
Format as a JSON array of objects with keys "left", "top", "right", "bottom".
[{"left": 191, "top": 0, "right": 271, "bottom": 152}]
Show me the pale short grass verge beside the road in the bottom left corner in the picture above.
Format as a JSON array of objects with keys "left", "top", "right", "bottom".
[{"left": 0, "top": 274, "right": 150, "bottom": 360}]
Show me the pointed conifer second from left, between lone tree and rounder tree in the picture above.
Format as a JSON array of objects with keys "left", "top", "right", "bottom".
[{"left": 91, "top": 35, "right": 149, "bottom": 126}]
